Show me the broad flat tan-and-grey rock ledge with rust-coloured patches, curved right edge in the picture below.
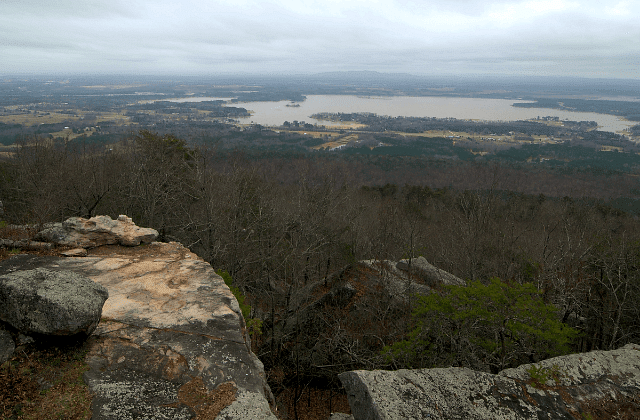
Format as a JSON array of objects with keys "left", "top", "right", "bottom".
[{"left": 0, "top": 242, "right": 276, "bottom": 420}]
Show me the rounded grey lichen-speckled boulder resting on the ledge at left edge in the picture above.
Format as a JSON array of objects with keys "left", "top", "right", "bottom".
[{"left": 0, "top": 268, "right": 109, "bottom": 335}]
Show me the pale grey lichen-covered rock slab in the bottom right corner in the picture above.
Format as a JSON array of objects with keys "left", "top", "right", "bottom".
[{"left": 339, "top": 344, "right": 640, "bottom": 420}]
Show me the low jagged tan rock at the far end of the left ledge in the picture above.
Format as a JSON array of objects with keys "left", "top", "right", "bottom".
[{"left": 36, "top": 215, "right": 158, "bottom": 248}]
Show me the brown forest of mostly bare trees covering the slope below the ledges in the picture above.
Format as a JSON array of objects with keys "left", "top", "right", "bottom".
[{"left": 0, "top": 131, "right": 640, "bottom": 416}]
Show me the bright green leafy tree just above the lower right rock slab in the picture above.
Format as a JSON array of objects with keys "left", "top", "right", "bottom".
[{"left": 385, "top": 278, "right": 578, "bottom": 372}]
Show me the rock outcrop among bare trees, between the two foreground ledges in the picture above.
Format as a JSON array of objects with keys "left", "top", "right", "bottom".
[{"left": 278, "top": 257, "right": 465, "bottom": 342}]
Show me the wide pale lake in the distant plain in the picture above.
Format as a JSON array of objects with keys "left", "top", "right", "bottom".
[{"left": 171, "top": 95, "right": 637, "bottom": 132}]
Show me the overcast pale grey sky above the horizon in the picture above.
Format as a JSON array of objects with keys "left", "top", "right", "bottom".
[{"left": 0, "top": 0, "right": 640, "bottom": 79}]
